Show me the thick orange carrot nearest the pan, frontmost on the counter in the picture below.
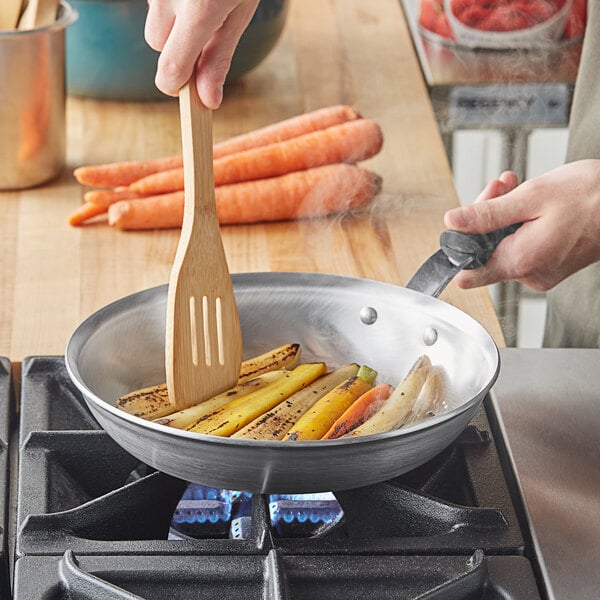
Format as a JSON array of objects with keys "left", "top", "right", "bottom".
[{"left": 108, "top": 163, "right": 381, "bottom": 229}]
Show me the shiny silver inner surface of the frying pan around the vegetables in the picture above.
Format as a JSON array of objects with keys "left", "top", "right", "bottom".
[{"left": 66, "top": 273, "right": 498, "bottom": 420}]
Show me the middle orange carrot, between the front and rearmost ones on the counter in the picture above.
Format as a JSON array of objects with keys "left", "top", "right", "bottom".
[{"left": 129, "top": 119, "right": 383, "bottom": 195}]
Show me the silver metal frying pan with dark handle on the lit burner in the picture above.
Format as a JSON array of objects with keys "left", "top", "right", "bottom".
[{"left": 66, "top": 225, "right": 511, "bottom": 493}]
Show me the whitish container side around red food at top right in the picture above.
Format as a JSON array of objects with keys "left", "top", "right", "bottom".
[{"left": 444, "top": 0, "right": 573, "bottom": 50}]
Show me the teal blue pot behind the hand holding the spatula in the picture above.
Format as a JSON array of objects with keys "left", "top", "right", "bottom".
[{"left": 66, "top": 0, "right": 289, "bottom": 101}]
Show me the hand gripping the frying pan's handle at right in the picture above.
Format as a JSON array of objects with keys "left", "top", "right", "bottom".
[{"left": 444, "top": 160, "right": 600, "bottom": 291}]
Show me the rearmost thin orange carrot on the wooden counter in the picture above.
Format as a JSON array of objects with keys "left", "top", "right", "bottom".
[{"left": 73, "top": 104, "right": 361, "bottom": 191}]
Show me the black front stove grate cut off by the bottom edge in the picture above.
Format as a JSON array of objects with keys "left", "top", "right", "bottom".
[{"left": 15, "top": 550, "right": 540, "bottom": 600}]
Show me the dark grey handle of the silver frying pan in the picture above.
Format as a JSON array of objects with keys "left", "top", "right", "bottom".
[{"left": 406, "top": 223, "right": 523, "bottom": 298}]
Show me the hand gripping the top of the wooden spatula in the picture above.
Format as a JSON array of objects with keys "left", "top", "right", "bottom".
[{"left": 144, "top": 0, "right": 259, "bottom": 109}]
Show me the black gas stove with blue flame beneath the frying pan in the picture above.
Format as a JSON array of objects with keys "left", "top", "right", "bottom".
[{"left": 0, "top": 357, "right": 546, "bottom": 600}]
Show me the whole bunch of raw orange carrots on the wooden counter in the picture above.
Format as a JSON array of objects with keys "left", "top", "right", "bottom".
[{"left": 69, "top": 105, "right": 383, "bottom": 230}]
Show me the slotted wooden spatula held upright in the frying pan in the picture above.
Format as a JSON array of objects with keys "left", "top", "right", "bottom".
[{"left": 166, "top": 77, "right": 242, "bottom": 409}]
